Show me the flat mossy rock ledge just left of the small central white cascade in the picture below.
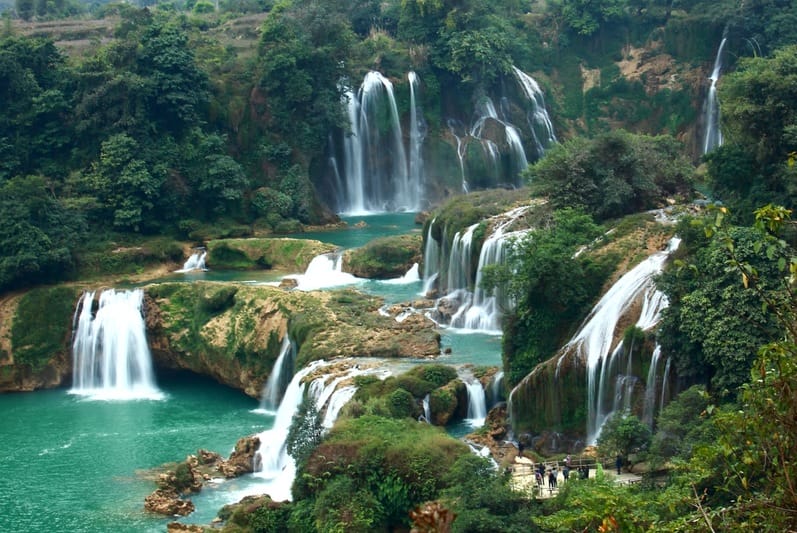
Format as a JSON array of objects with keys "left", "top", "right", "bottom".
[{"left": 207, "top": 238, "right": 335, "bottom": 272}]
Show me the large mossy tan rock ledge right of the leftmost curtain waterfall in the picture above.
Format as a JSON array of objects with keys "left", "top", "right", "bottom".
[{"left": 145, "top": 282, "right": 440, "bottom": 397}]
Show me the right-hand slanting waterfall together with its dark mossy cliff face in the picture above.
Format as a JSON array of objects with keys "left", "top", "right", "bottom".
[{"left": 509, "top": 238, "right": 680, "bottom": 444}]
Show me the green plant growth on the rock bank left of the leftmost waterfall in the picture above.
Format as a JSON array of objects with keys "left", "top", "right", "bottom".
[{"left": 11, "top": 287, "right": 78, "bottom": 370}]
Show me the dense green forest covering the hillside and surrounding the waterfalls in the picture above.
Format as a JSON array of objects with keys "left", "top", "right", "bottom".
[{"left": 0, "top": 0, "right": 797, "bottom": 531}]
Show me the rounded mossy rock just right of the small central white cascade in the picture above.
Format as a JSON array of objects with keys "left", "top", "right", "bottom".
[{"left": 343, "top": 234, "right": 423, "bottom": 279}]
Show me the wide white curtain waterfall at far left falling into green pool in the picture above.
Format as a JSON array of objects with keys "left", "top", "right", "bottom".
[{"left": 70, "top": 289, "right": 163, "bottom": 400}]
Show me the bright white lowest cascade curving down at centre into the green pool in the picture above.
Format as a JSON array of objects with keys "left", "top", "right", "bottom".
[{"left": 253, "top": 359, "right": 388, "bottom": 501}]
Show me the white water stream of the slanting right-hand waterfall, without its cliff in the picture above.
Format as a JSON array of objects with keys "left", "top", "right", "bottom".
[{"left": 566, "top": 237, "right": 680, "bottom": 444}]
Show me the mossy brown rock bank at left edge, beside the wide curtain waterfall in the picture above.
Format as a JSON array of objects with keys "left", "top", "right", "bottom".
[{"left": 0, "top": 286, "right": 79, "bottom": 392}]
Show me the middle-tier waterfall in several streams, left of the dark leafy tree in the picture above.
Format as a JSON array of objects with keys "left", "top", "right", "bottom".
[{"left": 424, "top": 206, "right": 530, "bottom": 334}]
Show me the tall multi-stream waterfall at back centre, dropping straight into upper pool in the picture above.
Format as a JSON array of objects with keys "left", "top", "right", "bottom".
[{"left": 338, "top": 71, "right": 425, "bottom": 214}]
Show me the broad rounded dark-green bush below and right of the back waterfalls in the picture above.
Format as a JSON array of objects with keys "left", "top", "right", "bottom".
[{"left": 527, "top": 130, "right": 693, "bottom": 221}]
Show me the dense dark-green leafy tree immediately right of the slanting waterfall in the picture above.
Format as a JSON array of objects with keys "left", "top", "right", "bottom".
[{"left": 659, "top": 221, "right": 779, "bottom": 394}]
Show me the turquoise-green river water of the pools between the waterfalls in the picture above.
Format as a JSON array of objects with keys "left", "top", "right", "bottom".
[{"left": 0, "top": 214, "right": 501, "bottom": 533}]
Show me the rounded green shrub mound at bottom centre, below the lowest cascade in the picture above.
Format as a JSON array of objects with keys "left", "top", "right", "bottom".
[{"left": 293, "top": 415, "right": 469, "bottom": 531}]
